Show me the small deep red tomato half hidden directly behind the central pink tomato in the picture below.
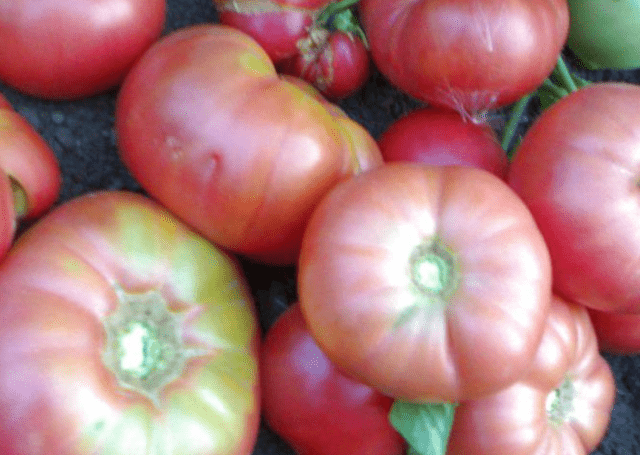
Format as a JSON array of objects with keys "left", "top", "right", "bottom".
[{"left": 378, "top": 108, "right": 509, "bottom": 179}]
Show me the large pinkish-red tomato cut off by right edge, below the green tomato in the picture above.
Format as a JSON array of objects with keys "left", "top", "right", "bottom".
[{"left": 508, "top": 83, "right": 640, "bottom": 312}]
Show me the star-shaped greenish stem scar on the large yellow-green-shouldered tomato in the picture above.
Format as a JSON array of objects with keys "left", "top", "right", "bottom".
[{"left": 102, "top": 288, "right": 209, "bottom": 408}]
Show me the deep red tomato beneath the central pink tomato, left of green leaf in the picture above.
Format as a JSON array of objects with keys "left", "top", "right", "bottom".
[{"left": 260, "top": 303, "right": 406, "bottom": 455}]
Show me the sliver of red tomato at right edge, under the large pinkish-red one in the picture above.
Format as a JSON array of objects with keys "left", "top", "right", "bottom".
[{"left": 589, "top": 309, "right": 640, "bottom": 355}]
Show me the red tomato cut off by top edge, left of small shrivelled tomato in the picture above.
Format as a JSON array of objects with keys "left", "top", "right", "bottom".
[{"left": 213, "top": 0, "right": 332, "bottom": 62}]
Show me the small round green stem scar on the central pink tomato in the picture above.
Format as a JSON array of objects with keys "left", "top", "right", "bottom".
[{"left": 409, "top": 239, "right": 458, "bottom": 300}]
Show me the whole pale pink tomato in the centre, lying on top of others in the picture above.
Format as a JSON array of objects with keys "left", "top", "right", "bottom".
[{"left": 298, "top": 162, "right": 551, "bottom": 402}]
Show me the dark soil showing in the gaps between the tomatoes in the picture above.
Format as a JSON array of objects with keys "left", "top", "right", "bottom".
[{"left": 0, "top": 0, "right": 640, "bottom": 455}]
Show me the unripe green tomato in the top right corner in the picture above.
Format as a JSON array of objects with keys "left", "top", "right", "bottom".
[{"left": 567, "top": 0, "right": 640, "bottom": 69}]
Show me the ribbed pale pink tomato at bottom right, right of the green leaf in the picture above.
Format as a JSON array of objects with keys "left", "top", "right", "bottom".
[{"left": 447, "top": 297, "right": 615, "bottom": 455}]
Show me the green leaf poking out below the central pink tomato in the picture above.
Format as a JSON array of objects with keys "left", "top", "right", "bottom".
[{"left": 389, "top": 400, "right": 456, "bottom": 455}]
